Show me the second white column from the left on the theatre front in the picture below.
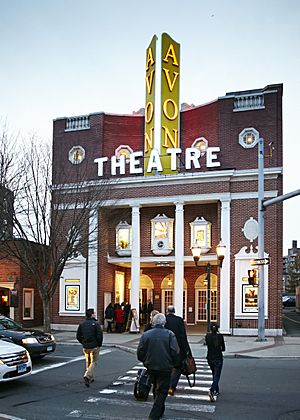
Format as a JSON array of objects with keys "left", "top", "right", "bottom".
[{"left": 130, "top": 205, "right": 141, "bottom": 315}]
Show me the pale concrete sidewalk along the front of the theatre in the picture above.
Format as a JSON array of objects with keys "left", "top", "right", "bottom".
[{"left": 53, "top": 331, "right": 300, "bottom": 358}]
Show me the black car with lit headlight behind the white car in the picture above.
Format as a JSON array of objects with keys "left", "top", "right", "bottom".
[{"left": 0, "top": 315, "right": 56, "bottom": 358}]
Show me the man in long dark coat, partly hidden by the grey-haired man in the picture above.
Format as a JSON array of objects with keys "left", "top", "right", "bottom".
[{"left": 165, "top": 305, "right": 191, "bottom": 396}]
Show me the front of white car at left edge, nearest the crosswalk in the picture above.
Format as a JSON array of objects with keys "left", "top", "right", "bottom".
[{"left": 0, "top": 340, "right": 32, "bottom": 383}]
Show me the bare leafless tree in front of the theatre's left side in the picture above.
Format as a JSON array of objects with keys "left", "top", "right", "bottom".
[{"left": 2, "top": 139, "right": 110, "bottom": 331}]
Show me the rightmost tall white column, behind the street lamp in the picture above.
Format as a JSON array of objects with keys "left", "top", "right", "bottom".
[{"left": 220, "top": 200, "right": 230, "bottom": 334}]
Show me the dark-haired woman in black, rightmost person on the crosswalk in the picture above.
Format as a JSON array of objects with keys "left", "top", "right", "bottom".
[{"left": 205, "top": 322, "right": 225, "bottom": 402}]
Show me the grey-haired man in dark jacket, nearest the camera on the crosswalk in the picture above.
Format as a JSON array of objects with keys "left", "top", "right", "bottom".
[{"left": 137, "top": 313, "right": 179, "bottom": 420}]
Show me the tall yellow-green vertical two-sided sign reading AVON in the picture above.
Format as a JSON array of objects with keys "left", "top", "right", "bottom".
[{"left": 144, "top": 33, "right": 180, "bottom": 175}]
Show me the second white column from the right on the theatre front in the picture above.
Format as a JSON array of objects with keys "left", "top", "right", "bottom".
[{"left": 174, "top": 202, "right": 184, "bottom": 317}]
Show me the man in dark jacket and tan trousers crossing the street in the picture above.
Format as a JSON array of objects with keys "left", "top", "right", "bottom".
[{"left": 76, "top": 309, "right": 103, "bottom": 386}]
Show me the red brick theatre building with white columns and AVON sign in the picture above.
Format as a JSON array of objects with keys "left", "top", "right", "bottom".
[{"left": 52, "top": 33, "right": 282, "bottom": 335}]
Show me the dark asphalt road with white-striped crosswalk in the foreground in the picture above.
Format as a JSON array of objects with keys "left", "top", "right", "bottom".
[{"left": 0, "top": 345, "right": 300, "bottom": 420}]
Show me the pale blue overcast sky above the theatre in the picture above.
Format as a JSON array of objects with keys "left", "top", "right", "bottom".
[{"left": 0, "top": 0, "right": 300, "bottom": 253}]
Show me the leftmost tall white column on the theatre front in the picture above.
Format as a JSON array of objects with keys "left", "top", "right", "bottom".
[{"left": 87, "top": 210, "right": 100, "bottom": 316}]
